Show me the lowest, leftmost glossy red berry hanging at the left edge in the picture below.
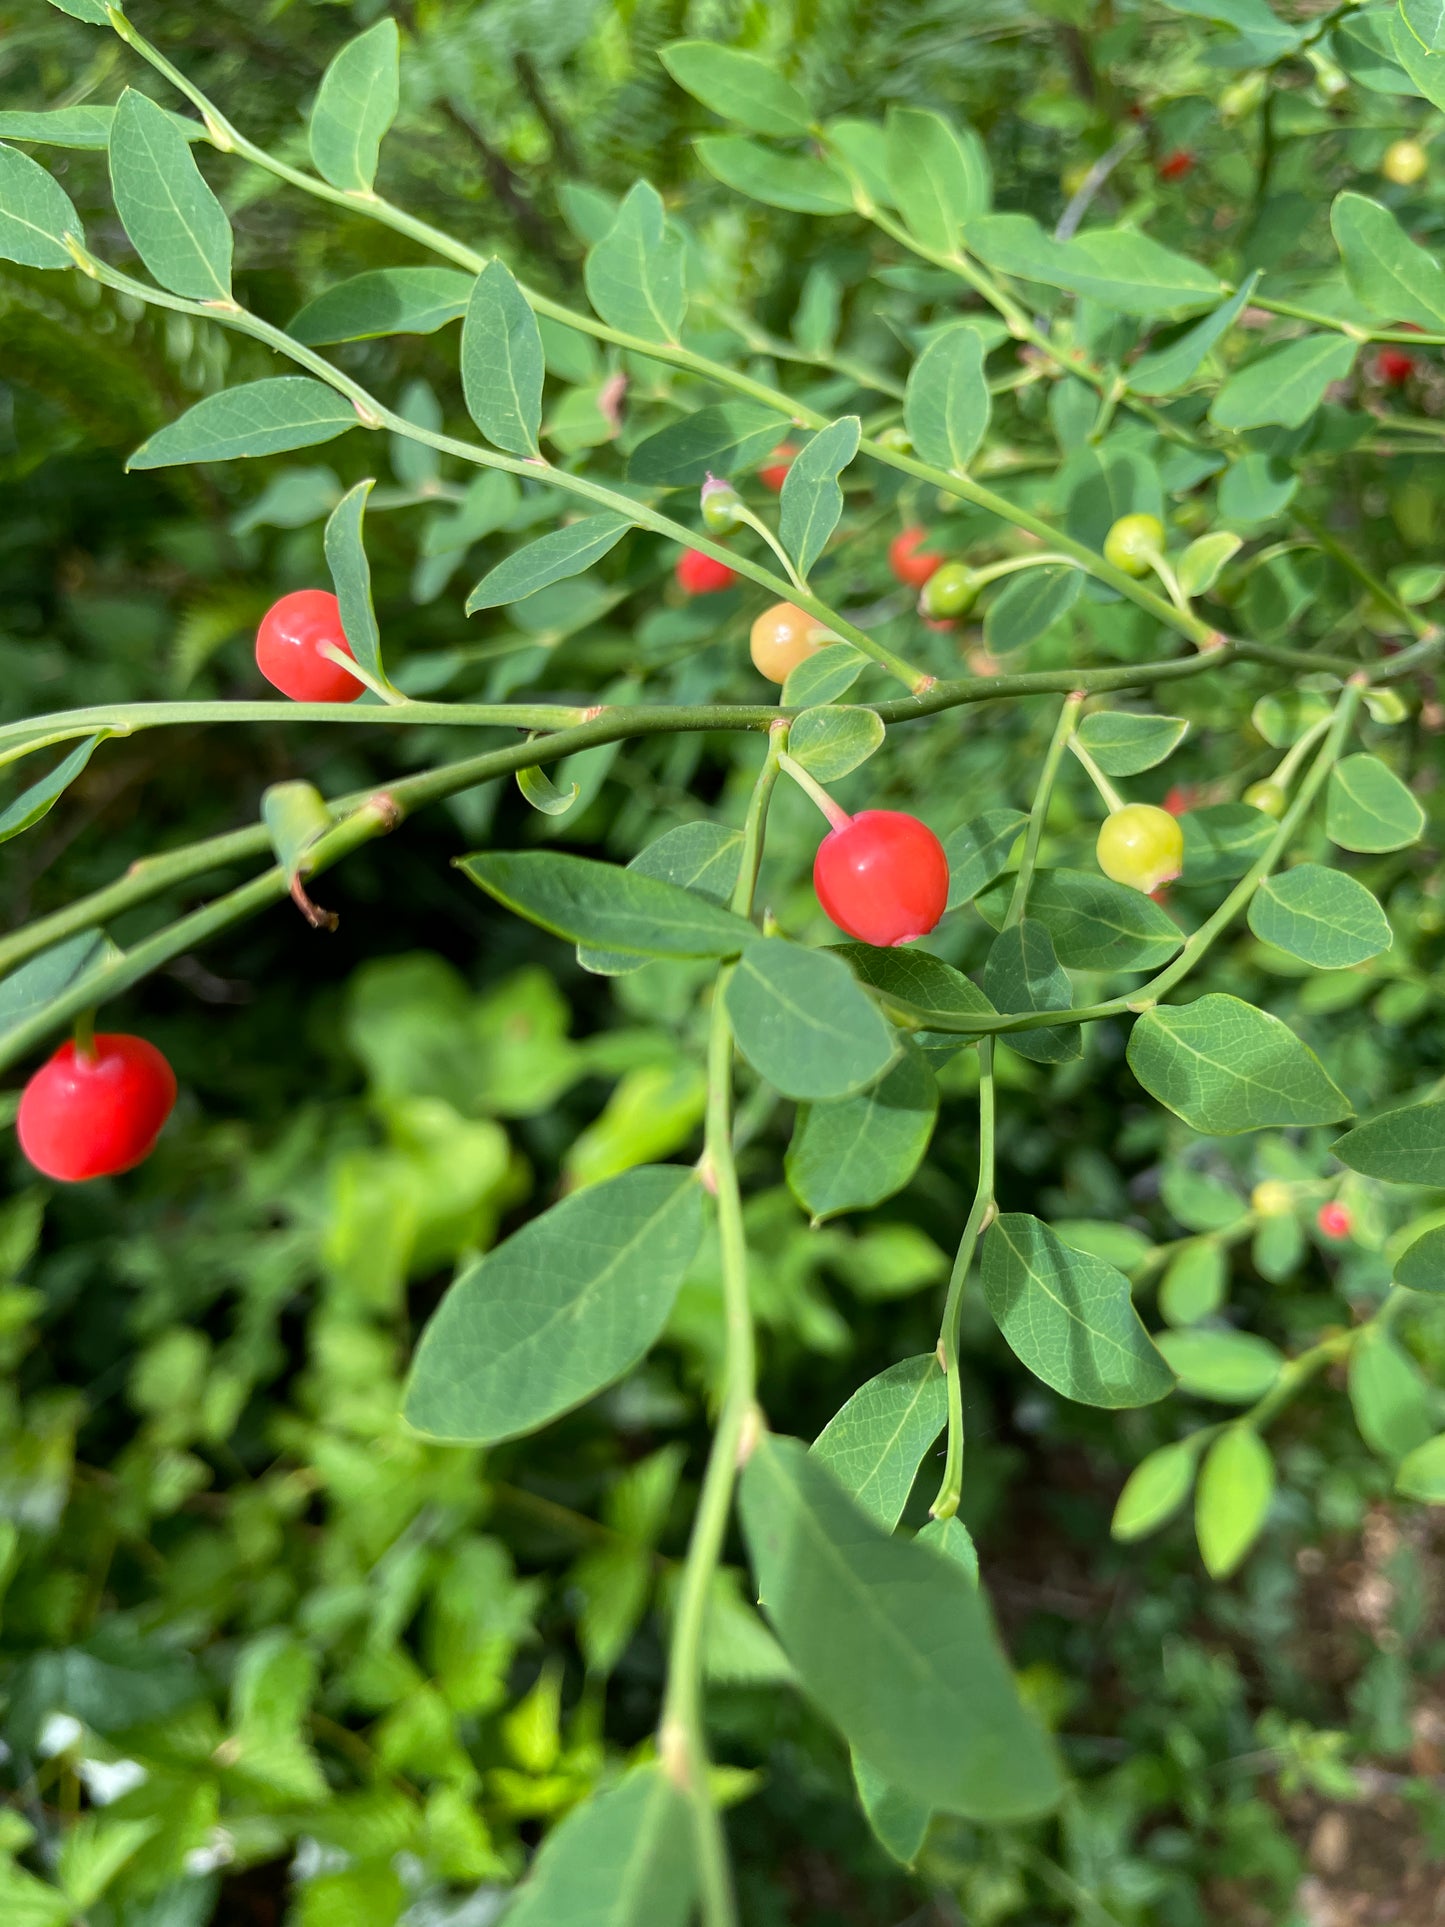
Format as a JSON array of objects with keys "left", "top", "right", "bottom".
[{"left": 15, "top": 1033, "right": 175, "bottom": 1185}]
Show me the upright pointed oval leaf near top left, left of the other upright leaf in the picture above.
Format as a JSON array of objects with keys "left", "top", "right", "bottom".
[{"left": 110, "top": 87, "right": 231, "bottom": 301}]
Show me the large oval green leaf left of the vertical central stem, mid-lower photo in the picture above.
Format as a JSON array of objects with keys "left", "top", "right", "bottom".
[{"left": 405, "top": 1164, "right": 703, "bottom": 1445}]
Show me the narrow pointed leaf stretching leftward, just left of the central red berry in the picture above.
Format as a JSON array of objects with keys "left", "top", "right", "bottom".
[{"left": 459, "top": 850, "right": 759, "bottom": 958}]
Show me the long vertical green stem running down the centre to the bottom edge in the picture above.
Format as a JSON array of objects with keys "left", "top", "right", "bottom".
[{"left": 659, "top": 723, "right": 788, "bottom": 1927}]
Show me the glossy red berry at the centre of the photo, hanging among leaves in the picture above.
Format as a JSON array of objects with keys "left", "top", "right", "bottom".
[{"left": 813, "top": 809, "right": 948, "bottom": 944}]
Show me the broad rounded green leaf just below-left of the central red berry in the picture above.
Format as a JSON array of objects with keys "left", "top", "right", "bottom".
[{"left": 726, "top": 937, "right": 898, "bottom": 1102}]
